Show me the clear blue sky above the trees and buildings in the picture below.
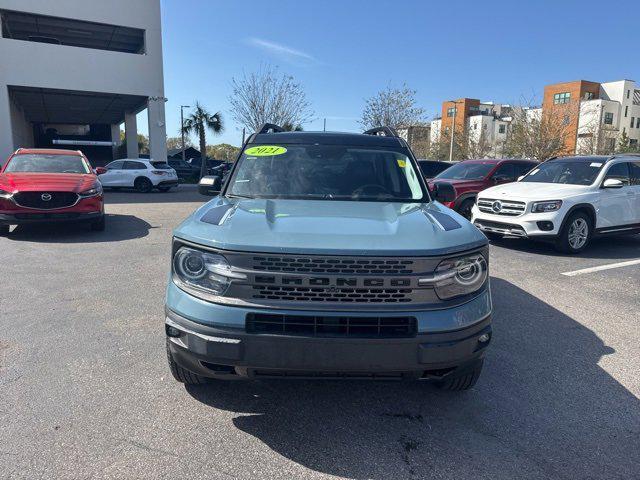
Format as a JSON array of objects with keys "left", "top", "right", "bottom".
[{"left": 159, "top": 0, "right": 640, "bottom": 145}]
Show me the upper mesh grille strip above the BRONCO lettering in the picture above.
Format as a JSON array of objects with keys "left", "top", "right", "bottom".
[{"left": 253, "top": 256, "right": 414, "bottom": 275}]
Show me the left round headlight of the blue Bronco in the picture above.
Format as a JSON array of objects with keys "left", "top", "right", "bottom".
[{"left": 173, "top": 247, "right": 247, "bottom": 296}]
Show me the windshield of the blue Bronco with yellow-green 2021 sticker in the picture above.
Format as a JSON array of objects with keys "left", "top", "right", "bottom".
[{"left": 227, "top": 145, "right": 425, "bottom": 201}]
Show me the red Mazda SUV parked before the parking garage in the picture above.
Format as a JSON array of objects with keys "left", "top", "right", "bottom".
[{"left": 0, "top": 148, "right": 105, "bottom": 235}]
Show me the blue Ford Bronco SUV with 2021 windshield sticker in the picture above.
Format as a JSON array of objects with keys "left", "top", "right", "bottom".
[{"left": 165, "top": 125, "right": 491, "bottom": 390}]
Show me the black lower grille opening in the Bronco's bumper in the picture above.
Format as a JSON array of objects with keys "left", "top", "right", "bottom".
[{"left": 246, "top": 313, "right": 418, "bottom": 338}]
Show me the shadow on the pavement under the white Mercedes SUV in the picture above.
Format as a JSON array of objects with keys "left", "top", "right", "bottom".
[{"left": 491, "top": 235, "right": 640, "bottom": 260}]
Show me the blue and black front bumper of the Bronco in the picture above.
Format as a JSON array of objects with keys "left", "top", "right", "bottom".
[{"left": 165, "top": 281, "right": 491, "bottom": 379}]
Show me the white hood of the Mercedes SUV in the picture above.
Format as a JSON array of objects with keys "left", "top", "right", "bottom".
[{"left": 479, "top": 182, "right": 590, "bottom": 201}]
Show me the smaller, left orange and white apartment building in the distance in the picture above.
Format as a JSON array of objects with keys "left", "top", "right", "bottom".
[{"left": 430, "top": 98, "right": 512, "bottom": 156}]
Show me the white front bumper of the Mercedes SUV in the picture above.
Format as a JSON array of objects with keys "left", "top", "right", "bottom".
[{"left": 471, "top": 205, "right": 564, "bottom": 239}]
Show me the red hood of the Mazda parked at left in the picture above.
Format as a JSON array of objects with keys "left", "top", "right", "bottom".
[{"left": 0, "top": 172, "right": 97, "bottom": 193}]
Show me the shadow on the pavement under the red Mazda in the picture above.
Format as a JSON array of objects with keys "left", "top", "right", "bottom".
[{"left": 6, "top": 214, "right": 155, "bottom": 243}]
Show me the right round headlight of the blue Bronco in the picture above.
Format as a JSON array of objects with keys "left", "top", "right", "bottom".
[{"left": 420, "top": 253, "right": 489, "bottom": 300}]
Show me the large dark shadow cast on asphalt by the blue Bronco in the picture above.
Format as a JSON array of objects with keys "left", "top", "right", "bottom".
[{"left": 182, "top": 278, "right": 640, "bottom": 479}]
